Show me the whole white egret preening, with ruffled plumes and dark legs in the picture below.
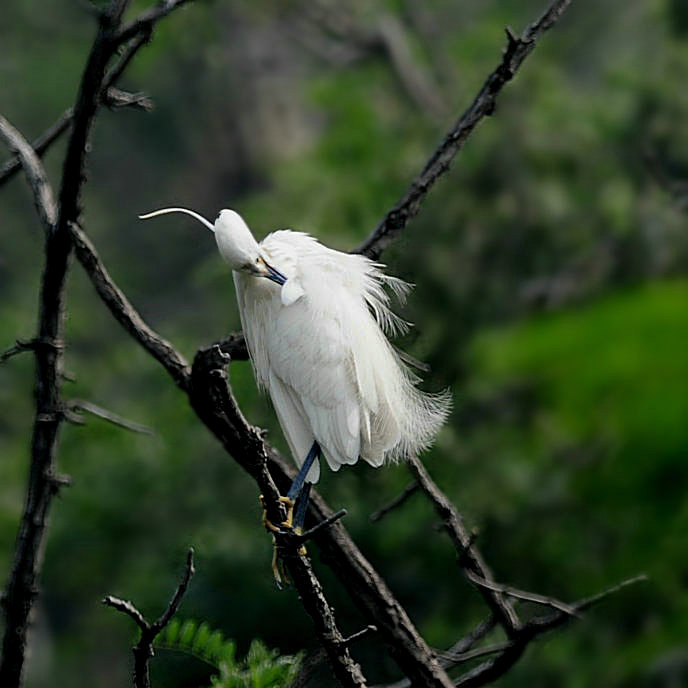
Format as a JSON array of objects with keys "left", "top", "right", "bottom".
[{"left": 140, "top": 208, "right": 450, "bottom": 540}]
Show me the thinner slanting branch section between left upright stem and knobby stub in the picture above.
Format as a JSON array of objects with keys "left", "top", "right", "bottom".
[{"left": 70, "top": 224, "right": 191, "bottom": 390}]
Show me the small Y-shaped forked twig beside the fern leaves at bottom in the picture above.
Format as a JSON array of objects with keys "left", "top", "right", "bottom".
[{"left": 103, "top": 547, "right": 195, "bottom": 688}]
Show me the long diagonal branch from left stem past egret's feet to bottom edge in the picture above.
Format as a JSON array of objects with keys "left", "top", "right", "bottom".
[{"left": 72, "top": 225, "right": 451, "bottom": 688}]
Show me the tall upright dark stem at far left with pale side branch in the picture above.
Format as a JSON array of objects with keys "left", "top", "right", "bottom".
[{"left": 0, "top": 0, "right": 198, "bottom": 688}]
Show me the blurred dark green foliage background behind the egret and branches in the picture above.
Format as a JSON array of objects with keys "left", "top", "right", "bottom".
[{"left": 0, "top": 0, "right": 688, "bottom": 688}]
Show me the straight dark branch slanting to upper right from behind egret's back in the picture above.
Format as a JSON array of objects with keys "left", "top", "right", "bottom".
[{"left": 355, "top": 0, "right": 571, "bottom": 259}]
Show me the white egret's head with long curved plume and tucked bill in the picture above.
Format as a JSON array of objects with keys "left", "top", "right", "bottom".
[{"left": 139, "top": 208, "right": 287, "bottom": 284}]
